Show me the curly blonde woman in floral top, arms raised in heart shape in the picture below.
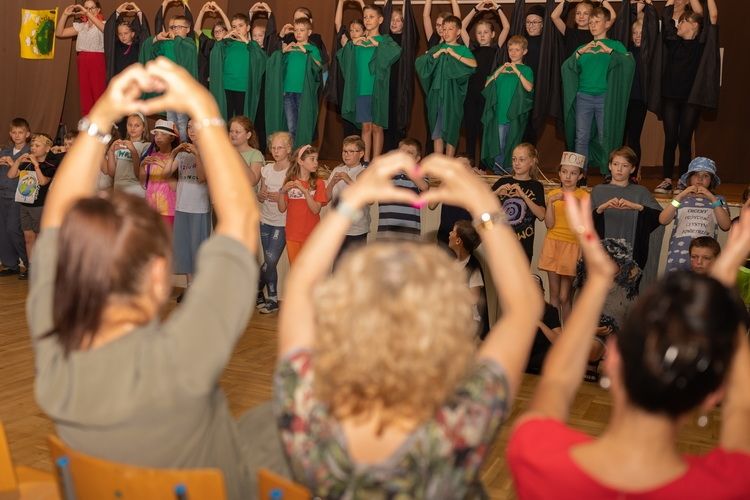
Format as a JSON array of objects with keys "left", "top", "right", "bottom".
[{"left": 274, "top": 153, "right": 541, "bottom": 498}]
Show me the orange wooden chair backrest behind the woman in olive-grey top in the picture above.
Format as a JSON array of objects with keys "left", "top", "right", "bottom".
[{"left": 47, "top": 436, "right": 226, "bottom": 500}]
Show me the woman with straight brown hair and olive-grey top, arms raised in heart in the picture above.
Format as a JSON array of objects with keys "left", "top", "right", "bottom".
[{"left": 28, "top": 60, "right": 258, "bottom": 498}]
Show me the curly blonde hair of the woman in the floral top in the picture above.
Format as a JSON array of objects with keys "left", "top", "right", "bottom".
[{"left": 313, "top": 242, "right": 475, "bottom": 429}]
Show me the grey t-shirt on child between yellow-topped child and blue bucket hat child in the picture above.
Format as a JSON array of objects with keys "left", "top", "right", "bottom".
[{"left": 591, "top": 184, "right": 661, "bottom": 247}]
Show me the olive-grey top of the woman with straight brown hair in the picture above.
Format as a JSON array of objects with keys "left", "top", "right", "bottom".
[{"left": 26, "top": 229, "right": 258, "bottom": 499}]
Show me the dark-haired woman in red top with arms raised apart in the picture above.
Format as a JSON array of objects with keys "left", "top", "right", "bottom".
[{"left": 508, "top": 193, "right": 750, "bottom": 499}]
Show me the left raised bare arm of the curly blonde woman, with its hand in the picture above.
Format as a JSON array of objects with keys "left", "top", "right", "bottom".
[{"left": 279, "top": 152, "right": 417, "bottom": 357}]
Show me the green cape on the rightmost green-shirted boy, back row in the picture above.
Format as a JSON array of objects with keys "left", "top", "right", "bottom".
[{"left": 562, "top": 51, "right": 635, "bottom": 175}]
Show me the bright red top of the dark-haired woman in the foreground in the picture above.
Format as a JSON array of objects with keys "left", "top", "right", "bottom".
[{"left": 507, "top": 419, "right": 750, "bottom": 500}]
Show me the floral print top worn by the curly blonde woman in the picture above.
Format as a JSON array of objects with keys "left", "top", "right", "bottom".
[{"left": 274, "top": 350, "right": 509, "bottom": 499}]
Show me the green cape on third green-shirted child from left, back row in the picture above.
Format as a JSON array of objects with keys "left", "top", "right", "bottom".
[{"left": 266, "top": 50, "right": 322, "bottom": 147}]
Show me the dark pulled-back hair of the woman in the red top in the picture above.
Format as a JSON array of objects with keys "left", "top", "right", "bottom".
[{"left": 617, "top": 272, "right": 747, "bottom": 418}]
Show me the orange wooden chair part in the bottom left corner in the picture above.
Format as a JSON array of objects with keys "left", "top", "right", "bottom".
[{"left": 0, "top": 422, "right": 60, "bottom": 500}]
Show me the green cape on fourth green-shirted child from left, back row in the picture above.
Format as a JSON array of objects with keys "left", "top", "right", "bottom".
[{"left": 336, "top": 35, "right": 401, "bottom": 128}]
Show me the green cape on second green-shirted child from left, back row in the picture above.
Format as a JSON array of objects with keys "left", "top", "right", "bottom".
[{"left": 208, "top": 40, "right": 268, "bottom": 123}]
